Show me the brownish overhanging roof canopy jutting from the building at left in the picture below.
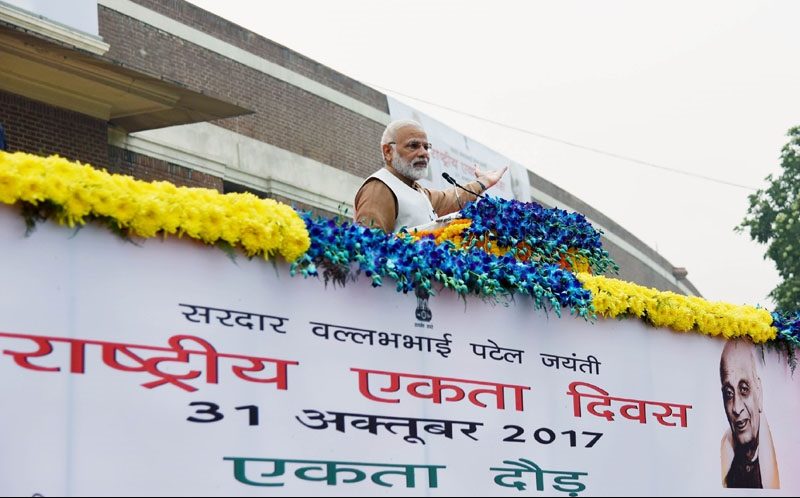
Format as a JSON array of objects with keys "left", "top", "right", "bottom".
[{"left": 0, "top": 22, "right": 253, "bottom": 132}]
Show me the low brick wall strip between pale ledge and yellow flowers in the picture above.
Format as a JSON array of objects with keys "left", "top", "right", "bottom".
[{"left": 106, "top": 145, "right": 223, "bottom": 192}]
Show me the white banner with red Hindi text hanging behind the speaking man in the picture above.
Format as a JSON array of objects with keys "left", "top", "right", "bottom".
[{"left": 387, "top": 97, "right": 531, "bottom": 202}]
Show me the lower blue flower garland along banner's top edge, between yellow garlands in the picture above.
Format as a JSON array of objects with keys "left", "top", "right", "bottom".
[{"left": 291, "top": 214, "right": 592, "bottom": 318}]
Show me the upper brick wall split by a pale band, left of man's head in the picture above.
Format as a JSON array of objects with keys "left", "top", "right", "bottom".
[{"left": 99, "top": 0, "right": 387, "bottom": 181}]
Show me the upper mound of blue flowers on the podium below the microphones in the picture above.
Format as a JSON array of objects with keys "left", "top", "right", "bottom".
[{"left": 461, "top": 196, "right": 619, "bottom": 274}]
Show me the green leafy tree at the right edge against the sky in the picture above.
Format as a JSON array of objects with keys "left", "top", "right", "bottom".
[{"left": 736, "top": 126, "right": 800, "bottom": 313}]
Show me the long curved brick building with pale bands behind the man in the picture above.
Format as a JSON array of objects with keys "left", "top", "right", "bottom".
[{"left": 0, "top": 0, "right": 699, "bottom": 295}]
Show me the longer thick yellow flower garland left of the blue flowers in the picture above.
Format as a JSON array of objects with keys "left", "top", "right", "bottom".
[{"left": 0, "top": 152, "right": 310, "bottom": 261}]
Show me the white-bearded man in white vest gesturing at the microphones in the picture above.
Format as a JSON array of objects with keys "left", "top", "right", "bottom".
[{"left": 355, "top": 120, "right": 508, "bottom": 233}]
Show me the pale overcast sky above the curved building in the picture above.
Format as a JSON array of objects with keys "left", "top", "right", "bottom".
[{"left": 191, "top": 0, "right": 800, "bottom": 308}]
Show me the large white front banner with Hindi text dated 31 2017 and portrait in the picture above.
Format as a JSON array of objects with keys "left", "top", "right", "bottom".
[{"left": 0, "top": 206, "right": 800, "bottom": 496}]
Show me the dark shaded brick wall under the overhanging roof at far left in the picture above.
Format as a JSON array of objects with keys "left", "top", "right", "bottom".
[{"left": 0, "top": 91, "right": 108, "bottom": 167}]
